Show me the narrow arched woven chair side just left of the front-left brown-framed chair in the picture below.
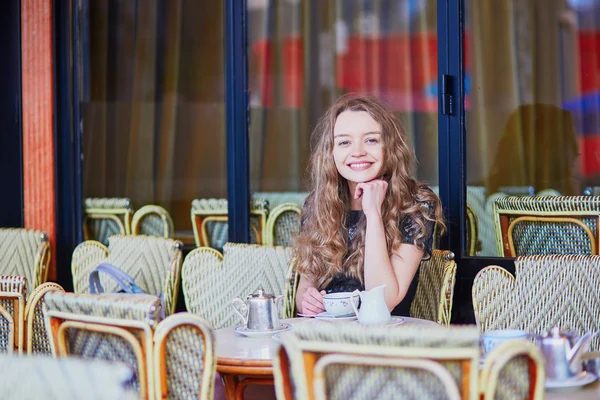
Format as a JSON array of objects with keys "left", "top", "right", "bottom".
[{"left": 26, "top": 282, "right": 65, "bottom": 355}]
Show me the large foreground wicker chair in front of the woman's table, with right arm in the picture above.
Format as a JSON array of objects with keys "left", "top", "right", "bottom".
[{"left": 273, "top": 324, "right": 544, "bottom": 399}]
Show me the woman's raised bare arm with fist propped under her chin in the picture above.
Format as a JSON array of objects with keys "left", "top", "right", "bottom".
[{"left": 355, "top": 180, "right": 423, "bottom": 310}]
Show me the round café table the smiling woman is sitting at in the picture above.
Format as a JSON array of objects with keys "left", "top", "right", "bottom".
[{"left": 216, "top": 317, "right": 437, "bottom": 400}]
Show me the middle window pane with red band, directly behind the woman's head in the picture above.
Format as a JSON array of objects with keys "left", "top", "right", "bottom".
[{"left": 248, "top": 0, "right": 438, "bottom": 244}]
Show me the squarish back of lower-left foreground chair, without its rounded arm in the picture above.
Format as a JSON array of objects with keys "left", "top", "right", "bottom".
[{"left": 44, "top": 292, "right": 160, "bottom": 399}]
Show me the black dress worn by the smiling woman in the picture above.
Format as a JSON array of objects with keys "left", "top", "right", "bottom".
[{"left": 320, "top": 198, "right": 435, "bottom": 316}]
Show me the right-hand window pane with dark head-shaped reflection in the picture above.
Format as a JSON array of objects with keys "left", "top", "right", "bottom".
[{"left": 464, "top": 0, "right": 600, "bottom": 257}]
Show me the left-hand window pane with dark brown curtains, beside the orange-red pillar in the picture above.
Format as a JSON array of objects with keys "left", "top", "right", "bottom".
[{"left": 78, "top": 0, "right": 227, "bottom": 243}]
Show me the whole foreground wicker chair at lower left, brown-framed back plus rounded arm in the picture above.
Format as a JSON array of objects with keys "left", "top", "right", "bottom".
[{"left": 45, "top": 293, "right": 216, "bottom": 400}]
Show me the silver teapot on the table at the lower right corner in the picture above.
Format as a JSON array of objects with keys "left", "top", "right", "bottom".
[{"left": 540, "top": 326, "right": 592, "bottom": 381}]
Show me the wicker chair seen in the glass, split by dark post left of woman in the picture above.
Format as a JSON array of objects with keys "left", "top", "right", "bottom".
[{"left": 191, "top": 199, "right": 269, "bottom": 251}]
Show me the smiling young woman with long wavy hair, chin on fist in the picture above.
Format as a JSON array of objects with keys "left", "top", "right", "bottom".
[{"left": 296, "top": 96, "right": 444, "bottom": 315}]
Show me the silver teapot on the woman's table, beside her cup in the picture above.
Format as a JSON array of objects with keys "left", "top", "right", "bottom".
[{"left": 231, "top": 287, "right": 283, "bottom": 331}]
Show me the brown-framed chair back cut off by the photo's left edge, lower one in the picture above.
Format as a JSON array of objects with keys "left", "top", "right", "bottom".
[{"left": 0, "top": 276, "right": 27, "bottom": 352}]
